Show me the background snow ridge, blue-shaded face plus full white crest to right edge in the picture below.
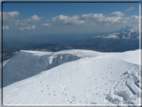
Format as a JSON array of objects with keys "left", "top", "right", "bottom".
[{"left": 3, "top": 49, "right": 139, "bottom": 86}]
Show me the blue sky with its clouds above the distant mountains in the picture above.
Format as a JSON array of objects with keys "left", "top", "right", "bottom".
[{"left": 3, "top": 3, "right": 139, "bottom": 36}]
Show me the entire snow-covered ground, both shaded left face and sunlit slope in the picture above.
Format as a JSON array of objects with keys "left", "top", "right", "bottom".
[{"left": 3, "top": 50, "right": 141, "bottom": 105}]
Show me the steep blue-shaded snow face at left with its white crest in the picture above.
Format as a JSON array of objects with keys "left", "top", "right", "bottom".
[{"left": 3, "top": 51, "right": 92, "bottom": 86}]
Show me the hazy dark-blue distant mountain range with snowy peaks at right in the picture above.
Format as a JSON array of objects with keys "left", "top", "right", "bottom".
[{"left": 3, "top": 30, "right": 139, "bottom": 60}]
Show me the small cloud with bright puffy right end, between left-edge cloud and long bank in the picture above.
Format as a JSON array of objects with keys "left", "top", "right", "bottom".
[{"left": 15, "top": 15, "right": 44, "bottom": 25}]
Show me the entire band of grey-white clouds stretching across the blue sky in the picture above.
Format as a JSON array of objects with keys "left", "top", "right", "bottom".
[{"left": 3, "top": 7, "right": 139, "bottom": 32}]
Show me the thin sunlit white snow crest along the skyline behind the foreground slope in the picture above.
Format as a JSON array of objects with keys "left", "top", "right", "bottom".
[{"left": 20, "top": 49, "right": 142, "bottom": 64}]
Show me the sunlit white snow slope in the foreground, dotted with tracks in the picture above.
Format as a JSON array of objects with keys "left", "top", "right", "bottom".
[{"left": 3, "top": 50, "right": 140, "bottom": 105}]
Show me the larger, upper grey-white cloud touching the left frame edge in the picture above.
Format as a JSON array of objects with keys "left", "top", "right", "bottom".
[{"left": 0, "top": 11, "right": 20, "bottom": 23}]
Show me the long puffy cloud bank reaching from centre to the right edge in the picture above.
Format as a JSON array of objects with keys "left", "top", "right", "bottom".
[{"left": 47, "top": 11, "right": 139, "bottom": 31}]
